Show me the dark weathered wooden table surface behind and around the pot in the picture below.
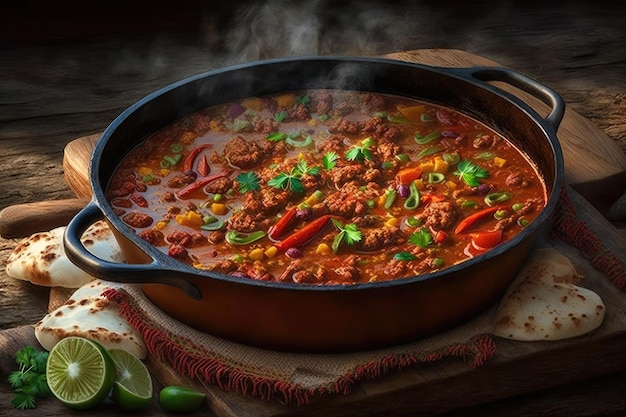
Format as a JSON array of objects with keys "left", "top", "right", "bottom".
[{"left": 0, "top": 0, "right": 626, "bottom": 416}]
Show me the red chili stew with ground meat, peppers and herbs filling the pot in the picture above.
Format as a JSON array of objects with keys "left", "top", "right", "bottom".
[{"left": 107, "top": 90, "right": 547, "bottom": 285}]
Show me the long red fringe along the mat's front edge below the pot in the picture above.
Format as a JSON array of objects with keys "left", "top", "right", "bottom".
[{"left": 102, "top": 289, "right": 496, "bottom": 405}]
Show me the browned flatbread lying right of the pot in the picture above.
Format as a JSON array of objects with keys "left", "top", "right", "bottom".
[{"left": 493, "top": 248, "right": 606, "bottom": 341}]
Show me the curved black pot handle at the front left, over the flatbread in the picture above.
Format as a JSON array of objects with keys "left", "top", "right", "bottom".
[{"left": 63, "top": 201, "right": 202, "bottom": 300}]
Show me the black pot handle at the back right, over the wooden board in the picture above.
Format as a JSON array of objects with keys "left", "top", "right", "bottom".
[{"left": 446, "top": 67, "right": 565, "bottom": 132}]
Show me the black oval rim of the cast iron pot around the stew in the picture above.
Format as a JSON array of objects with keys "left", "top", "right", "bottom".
[{"left": 90, "top": 56, "right": 564, "bottom": 291}]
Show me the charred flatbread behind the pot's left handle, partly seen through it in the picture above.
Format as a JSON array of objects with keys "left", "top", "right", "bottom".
[{"left": 6, "top": 220, "right": 122, "bottom": 288}]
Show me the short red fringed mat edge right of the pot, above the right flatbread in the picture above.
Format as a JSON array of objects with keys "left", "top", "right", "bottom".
[{"left": 551, "top": 188, "right": 626, "bottom": 289}]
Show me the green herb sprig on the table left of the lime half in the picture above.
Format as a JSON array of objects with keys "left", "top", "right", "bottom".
[{"left": 9, "top": 346, "right": 51, "bottom": 410}]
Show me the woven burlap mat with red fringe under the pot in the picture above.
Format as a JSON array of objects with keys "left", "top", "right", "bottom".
[{"left": 103, "top": 189, "right": 626, "bottom": 405}]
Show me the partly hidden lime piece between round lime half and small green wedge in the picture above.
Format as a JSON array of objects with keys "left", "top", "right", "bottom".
[{"left": 109, "top": 349, "right": 152, "bottom": 411}]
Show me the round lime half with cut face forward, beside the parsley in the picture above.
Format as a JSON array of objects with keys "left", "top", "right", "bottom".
[{"left": 46, "top": 336, "right": 115, "bottom": 410}]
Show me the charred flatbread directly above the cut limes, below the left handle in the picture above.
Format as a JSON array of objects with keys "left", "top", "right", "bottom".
[{"left": 35, "top": 280, "right": 147, "bottom": 359}]
